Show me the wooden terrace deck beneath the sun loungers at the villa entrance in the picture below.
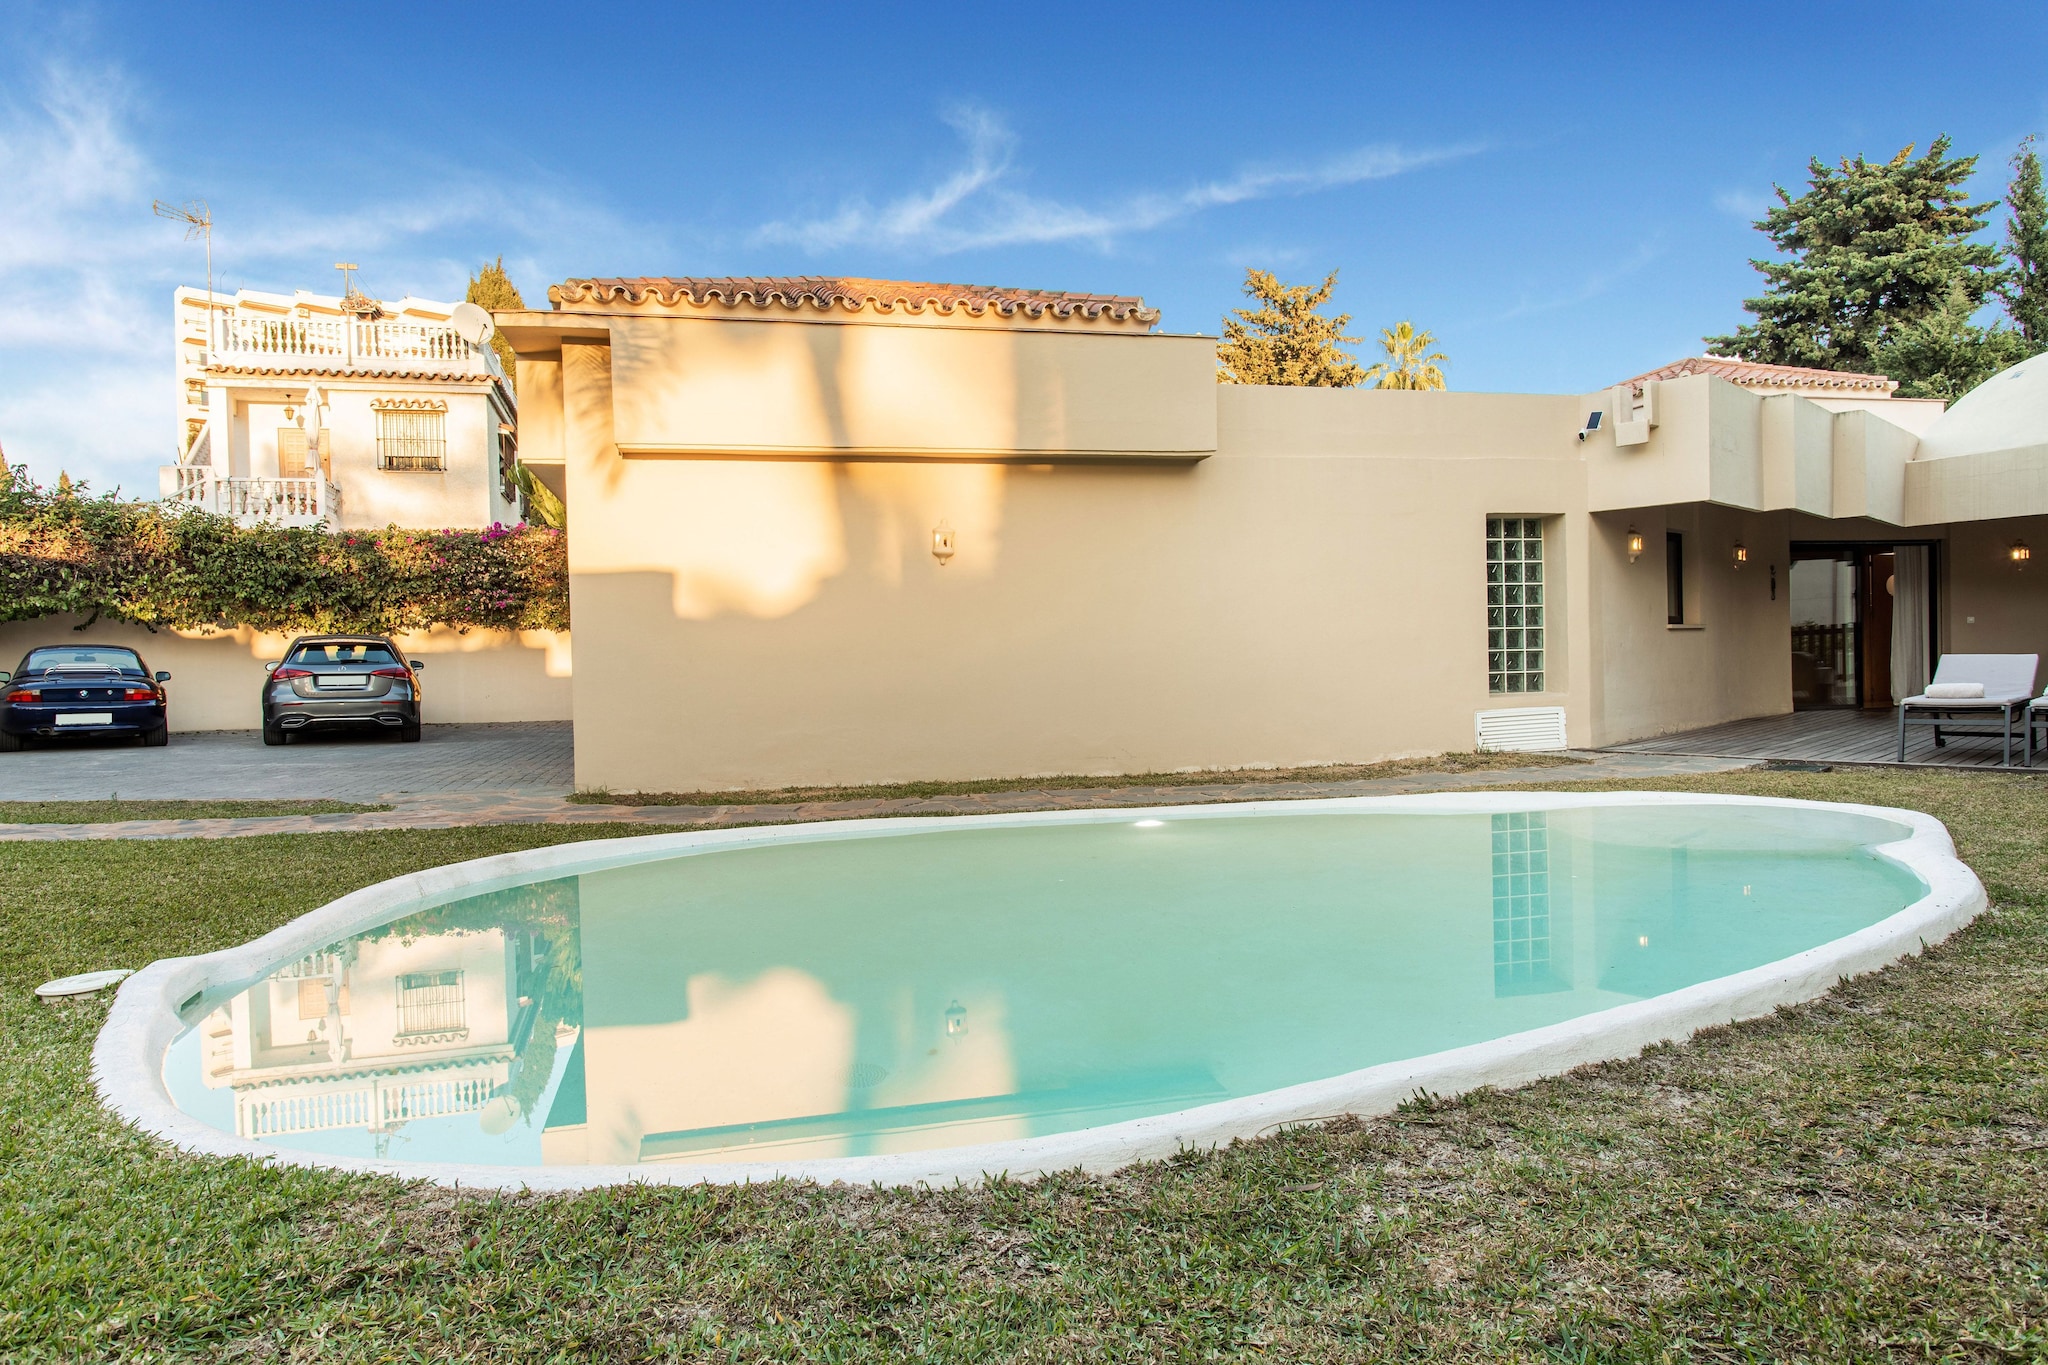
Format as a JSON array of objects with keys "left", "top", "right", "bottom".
[{"left": 1608, "top": 710, "right": 2048, "bottom": 772}]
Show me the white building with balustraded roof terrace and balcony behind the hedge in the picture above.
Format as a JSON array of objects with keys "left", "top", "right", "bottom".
[{"left": 160, "top": 287, "right": 520, "bottom": 528}]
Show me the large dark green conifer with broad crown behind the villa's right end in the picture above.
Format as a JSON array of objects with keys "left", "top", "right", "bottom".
[{"left": 1706, "top": 135, "right": 1999, "bottom": 381}]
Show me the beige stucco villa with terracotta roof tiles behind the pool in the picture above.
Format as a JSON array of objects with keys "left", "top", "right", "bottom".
[{"left": 498, "top": 276, "right": 2048, "bottom": 790}]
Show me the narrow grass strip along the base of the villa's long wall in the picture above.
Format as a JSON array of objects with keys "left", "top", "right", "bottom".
[{"left": 569, "top": 753, "right": 1585, "bottom": 806}]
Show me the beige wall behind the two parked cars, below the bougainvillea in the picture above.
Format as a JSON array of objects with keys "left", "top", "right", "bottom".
[{"left": 0, "top": 616, "right": 571, "bottom": 731}]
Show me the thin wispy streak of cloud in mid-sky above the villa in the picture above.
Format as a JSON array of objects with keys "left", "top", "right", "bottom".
[{"left": 756, "top": 106, "right": 1481, "bottom": 256}]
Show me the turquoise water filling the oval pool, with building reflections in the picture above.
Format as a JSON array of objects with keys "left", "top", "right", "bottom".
[{"left": 166, "top": 804, "right": 1925, "bottom": 1164}]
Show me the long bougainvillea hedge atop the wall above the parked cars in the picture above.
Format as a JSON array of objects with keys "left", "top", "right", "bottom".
[{"left": 0, "top": 467, "right": 569, "bottom": 634}]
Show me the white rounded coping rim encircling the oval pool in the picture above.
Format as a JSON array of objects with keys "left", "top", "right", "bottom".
[{"left": 92, "top": 792, "right": 1987, "bottom": 1191}]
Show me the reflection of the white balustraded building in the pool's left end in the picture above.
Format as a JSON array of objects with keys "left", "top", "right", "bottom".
[{"left": 199, "top": 878, "right": 582, "bottom": 1154}]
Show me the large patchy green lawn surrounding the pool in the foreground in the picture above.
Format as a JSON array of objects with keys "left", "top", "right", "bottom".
[{"left": 0, "top": 772, "right": 2048, "bottom": 1361}]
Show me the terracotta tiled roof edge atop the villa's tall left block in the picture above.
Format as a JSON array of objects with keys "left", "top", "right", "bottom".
[{"left": 547, "top": 274, "right": 1159, "bottom": 323}]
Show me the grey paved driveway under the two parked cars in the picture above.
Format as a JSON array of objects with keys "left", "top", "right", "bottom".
[{"left": 0, "top": 720, "right": 575, "bottom": 800}]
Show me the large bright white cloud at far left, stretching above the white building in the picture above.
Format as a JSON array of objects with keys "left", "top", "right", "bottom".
[{"left": 0, "top": 59, "right": 659, "bottom": 493}]
